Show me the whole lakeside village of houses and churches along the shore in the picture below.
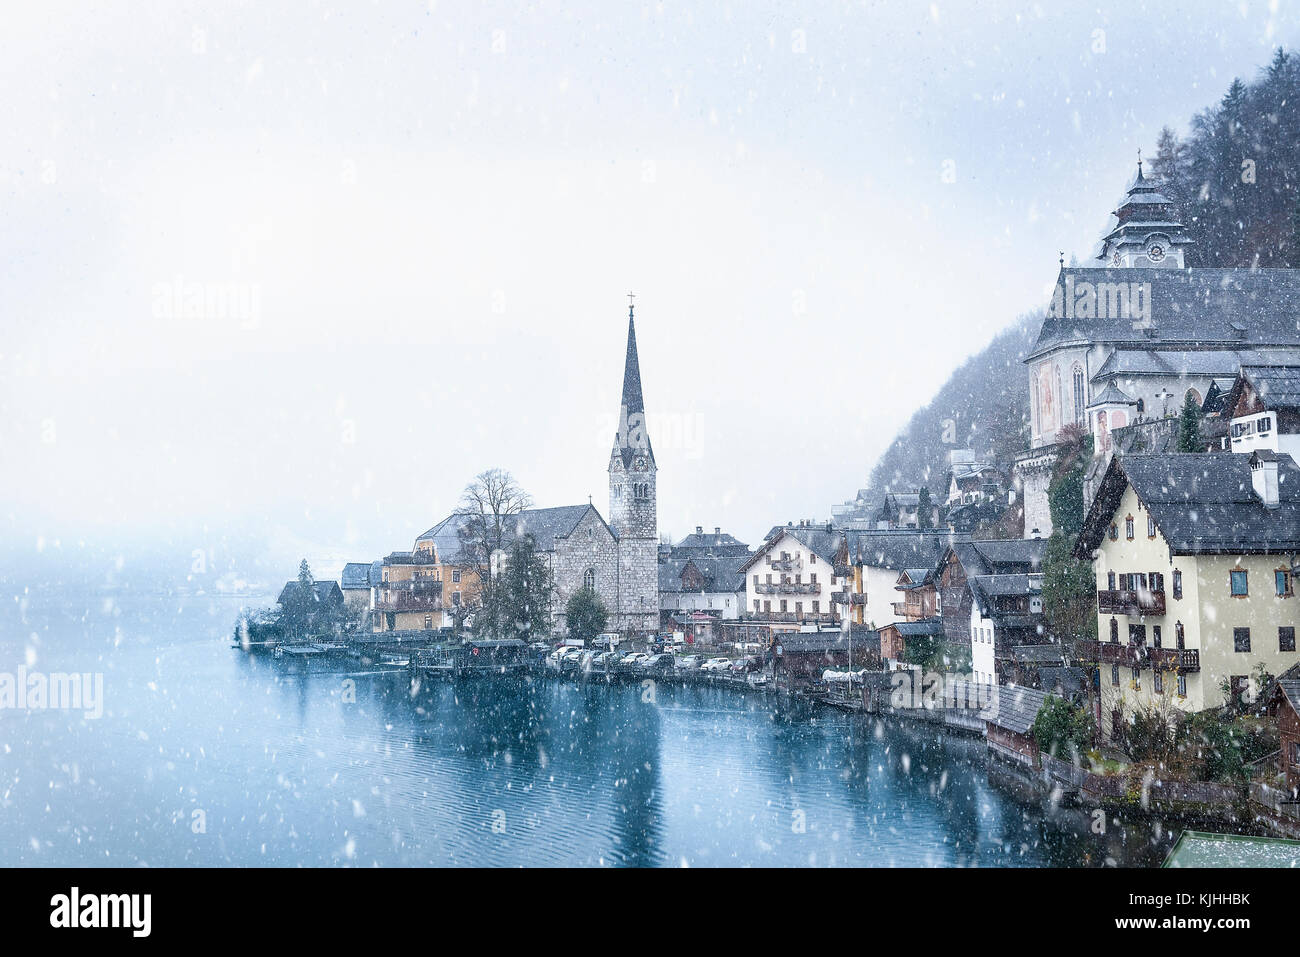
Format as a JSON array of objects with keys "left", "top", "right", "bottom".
[{"left": 237, "top": 164, "right": 1300, "bottom": 859}]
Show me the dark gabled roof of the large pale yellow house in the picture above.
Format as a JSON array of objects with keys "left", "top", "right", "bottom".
[{"left": 1075, "top": 452, "right": 1300, "bottom": 558}]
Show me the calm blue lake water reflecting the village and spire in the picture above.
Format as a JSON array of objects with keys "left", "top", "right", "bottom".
[{"left": 0, "top": 594, "right": 1177, "bottom": 866}]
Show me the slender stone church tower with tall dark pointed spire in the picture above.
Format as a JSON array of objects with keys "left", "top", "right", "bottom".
[{"left": 610, "top": 299, "right": 659, "bottom": 632}]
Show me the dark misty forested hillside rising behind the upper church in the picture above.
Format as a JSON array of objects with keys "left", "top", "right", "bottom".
[{"left": 868, "top": 49, "right": 1300, "bottom": 494}]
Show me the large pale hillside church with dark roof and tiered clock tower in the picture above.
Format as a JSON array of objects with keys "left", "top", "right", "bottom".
[{"left": 1015, "top": 165, "right": 1300, "bottom": 537}]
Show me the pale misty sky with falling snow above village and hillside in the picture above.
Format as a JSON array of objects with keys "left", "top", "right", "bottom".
[{"left": 0, "top": 0, "right": 1300, "bottom": 579}]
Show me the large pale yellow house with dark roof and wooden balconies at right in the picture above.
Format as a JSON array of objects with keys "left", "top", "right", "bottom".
[{"left": 1075, "top": 451, "right": 1300, "bottom": 740}]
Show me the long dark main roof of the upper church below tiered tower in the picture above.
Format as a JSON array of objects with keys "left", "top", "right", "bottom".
[{"left": 1026, "top": 267, "right": 1300, "bottom": 361}]
